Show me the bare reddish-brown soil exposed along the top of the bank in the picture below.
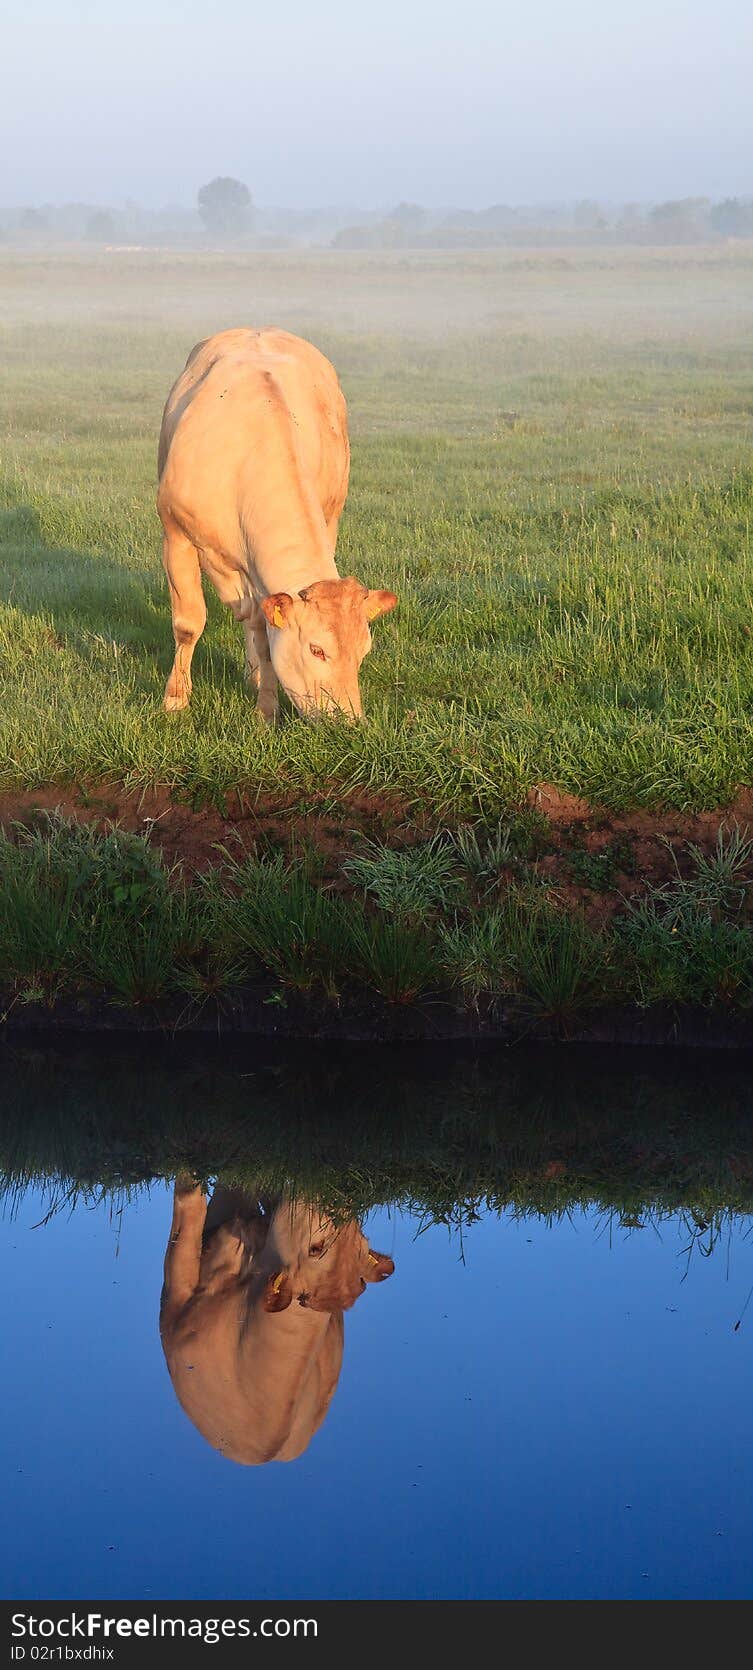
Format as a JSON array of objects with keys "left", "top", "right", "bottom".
[{"left": 0, "top": 768, "right": 753, "bottom": 925}]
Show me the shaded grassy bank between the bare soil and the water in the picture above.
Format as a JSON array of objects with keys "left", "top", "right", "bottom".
[{"left": 0, "top": 812, "right": 753, "bottom": 1034}]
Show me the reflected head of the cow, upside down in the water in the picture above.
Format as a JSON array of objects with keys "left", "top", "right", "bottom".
[{"left": 264, "top": 1216, "right": 394, "bottom": 1311}]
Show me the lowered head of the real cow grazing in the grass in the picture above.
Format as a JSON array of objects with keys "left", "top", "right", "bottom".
[{"left": 262, "top": 579, "right": 397, "bottom": 720}]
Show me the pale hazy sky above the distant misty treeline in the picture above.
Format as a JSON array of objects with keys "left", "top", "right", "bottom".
[{"left": 0, "top": 0, "right": 753, "bottom": 207}]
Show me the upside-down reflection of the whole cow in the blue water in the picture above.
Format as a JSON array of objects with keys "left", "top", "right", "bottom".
[{"left": 160, "top": 1179, "right": 394, "bottom": 1465}]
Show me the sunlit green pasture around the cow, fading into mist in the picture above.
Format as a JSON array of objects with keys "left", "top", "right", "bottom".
[{"left": 0, "top": 245, "right": 753, "bottom": 822}]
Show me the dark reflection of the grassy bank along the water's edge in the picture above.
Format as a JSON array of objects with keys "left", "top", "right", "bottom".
[{"left": 0, "top": 1040, "right": 753, "bottom": 1234}]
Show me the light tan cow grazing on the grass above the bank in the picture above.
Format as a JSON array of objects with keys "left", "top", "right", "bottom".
[{"left": 157, "top": 331, "right": 397, "bottom": 720}]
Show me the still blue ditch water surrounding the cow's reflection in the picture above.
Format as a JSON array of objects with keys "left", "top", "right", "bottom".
[{"left": 0, "top": 1054, "right": 753, "bottom": 1600}]
